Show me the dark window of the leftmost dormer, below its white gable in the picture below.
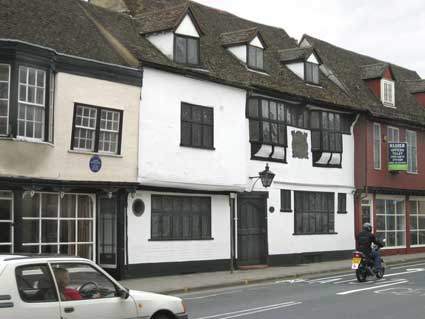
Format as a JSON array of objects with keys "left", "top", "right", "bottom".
[{"left": 174, "top": 34, "right": 199, "bottom": 65}]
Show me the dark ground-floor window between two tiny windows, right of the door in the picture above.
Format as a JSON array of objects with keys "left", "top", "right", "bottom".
[{"left": 294, "top": 191, "right": 335, "bottom": 235}]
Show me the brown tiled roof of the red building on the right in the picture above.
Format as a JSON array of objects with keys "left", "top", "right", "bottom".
[{"left": 303, "top": 35, "right": 425, "bottom": 124}]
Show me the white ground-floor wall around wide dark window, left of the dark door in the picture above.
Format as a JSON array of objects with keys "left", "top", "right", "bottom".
[{"left": 128, "top": 191, "right": 230, "bottom": 264}]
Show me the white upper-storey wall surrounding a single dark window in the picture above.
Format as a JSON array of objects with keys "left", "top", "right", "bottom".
[{"left": 139, "top": 68, "right": 249, "bottom": 190}]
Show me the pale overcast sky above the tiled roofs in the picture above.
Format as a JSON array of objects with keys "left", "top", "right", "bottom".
[{"left": 195, "top": 0, "right": 425, "bottom": 78}]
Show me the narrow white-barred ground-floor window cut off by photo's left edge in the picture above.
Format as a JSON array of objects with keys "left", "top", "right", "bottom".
[{"left": 0, "top": 191, "right": 13, "bottom": 254}]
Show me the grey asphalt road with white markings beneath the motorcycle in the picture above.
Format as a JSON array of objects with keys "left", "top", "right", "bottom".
[{"left": 175, "top": 263, "right": 425, "bottom": 319}]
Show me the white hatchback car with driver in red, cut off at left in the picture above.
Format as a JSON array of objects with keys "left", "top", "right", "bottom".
[{"left": 0, "top": 255, "right": 188, "bottom": 319}]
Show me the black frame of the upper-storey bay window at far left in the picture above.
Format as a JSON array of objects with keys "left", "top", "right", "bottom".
[{"left": 0, "top": 56, "right": 56, "bottom": 144}]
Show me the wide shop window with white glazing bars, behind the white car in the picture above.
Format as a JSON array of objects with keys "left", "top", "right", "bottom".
[{"left": 22, "top": 193, "right": 94, "bottom": 259}]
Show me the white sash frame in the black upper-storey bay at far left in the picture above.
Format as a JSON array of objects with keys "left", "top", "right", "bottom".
[{"left": 16, "top": 65, "right": 47, "bottom": 141}]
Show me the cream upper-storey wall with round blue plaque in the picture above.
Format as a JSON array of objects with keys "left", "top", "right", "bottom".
[{"left": 0, "top": 73, "right": 140, "bottom": 182}]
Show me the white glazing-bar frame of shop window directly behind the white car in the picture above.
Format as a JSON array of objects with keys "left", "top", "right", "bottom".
[{"left": 22, "top": 192, "right": 97, "bottom": 260}]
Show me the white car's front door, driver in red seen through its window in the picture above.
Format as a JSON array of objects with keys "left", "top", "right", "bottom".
[{"left": 51, "top": 262, "right": 137, "bottom": 319}]
